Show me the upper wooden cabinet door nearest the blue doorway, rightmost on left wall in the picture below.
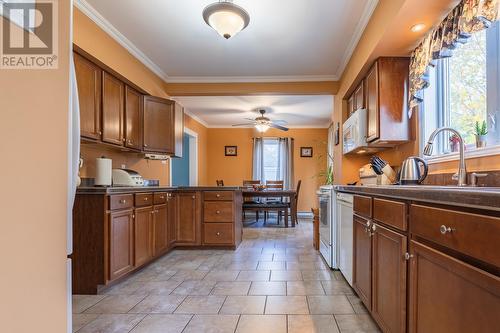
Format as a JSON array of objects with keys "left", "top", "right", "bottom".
[{"left": 143, "top": 96, "right": 175, "bottom": 154}]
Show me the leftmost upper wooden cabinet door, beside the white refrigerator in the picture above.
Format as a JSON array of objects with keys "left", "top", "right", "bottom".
[{"left": 73, "top": 53, "right": 102, "bottom": 140}]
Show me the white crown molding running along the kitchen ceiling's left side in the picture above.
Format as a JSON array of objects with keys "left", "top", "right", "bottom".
[{"left": 74, "top": 0, "right": 168, "bottom": 81}]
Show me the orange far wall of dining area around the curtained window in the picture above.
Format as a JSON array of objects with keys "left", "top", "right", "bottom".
[{"left": 207, "top": 128, "right": 328, "bottom": 212}]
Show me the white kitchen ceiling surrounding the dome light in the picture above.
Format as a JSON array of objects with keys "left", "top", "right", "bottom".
[{"left": 75, "top": 0, "right": 378, "bottom": 82}]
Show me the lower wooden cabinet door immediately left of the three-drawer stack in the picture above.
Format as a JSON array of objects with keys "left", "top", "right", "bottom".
[{"left": 176, "top": 192, "right": 201, "bottom": 245}]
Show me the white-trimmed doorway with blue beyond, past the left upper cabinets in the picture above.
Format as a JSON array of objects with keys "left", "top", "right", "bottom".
[{"left": 170, "top": 128, "right": 198, "bottom": 186}]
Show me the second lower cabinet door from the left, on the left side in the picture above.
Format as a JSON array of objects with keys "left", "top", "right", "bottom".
[{"left": 134, "top": 207, "right": 153, "bottom": 267}]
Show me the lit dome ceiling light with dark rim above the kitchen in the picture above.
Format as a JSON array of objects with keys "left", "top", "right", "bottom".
[{"left": 203, "top": 0, "right": 250, "bottom": 39}]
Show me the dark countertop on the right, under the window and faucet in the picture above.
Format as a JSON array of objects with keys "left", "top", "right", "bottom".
[{"left": 335, "top": 185, "right": 500, "bottom": 211}]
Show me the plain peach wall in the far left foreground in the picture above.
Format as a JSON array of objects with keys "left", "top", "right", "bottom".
[{"left": 0, "top": 1, "right": 71, "bottom": 333}]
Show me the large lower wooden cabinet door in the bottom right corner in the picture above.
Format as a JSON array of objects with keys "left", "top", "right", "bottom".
[{"left": 409, "top": 241, "right": 500, "bottom": 333}]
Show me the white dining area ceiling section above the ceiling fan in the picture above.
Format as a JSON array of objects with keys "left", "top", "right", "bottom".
[{"left": 175, "top": 95, "right": 333, "bottom": 128}]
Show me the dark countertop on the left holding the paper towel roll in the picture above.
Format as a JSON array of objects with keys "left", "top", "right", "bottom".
[{"left": 76, "top": 186, "right": 241, "bottom": 194}]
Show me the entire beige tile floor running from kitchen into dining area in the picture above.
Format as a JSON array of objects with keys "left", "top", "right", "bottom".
[{"left": 73, "top": 220, "right": 379, "bottom": 333}]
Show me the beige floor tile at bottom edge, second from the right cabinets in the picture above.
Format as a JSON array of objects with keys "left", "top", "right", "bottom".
[{"left": 288, "top": 315, "right": 339, "bottom": 333}]
